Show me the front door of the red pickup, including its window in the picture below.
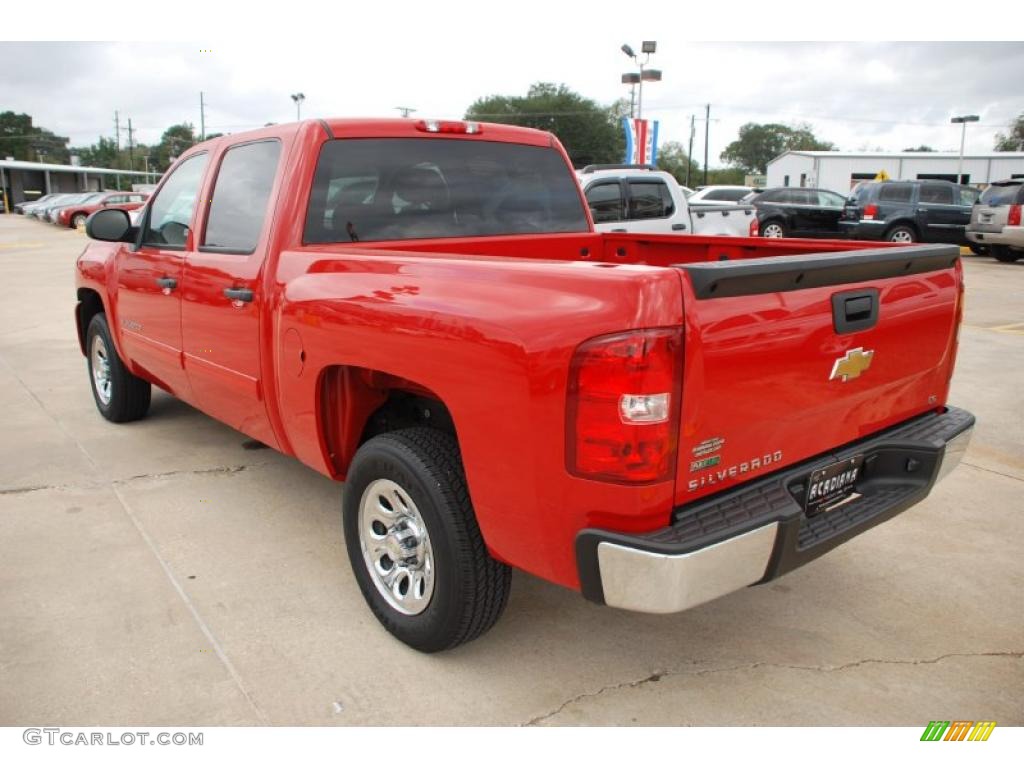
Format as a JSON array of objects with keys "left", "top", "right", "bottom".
[{"left": 117, "top": 153, "right": 207, "bottom": 400}]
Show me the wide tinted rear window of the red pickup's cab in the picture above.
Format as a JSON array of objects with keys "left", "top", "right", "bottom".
[{"left": 304, "top": 138, "right": 589, "bottom": 243}]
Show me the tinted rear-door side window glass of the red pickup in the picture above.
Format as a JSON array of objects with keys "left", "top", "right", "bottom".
[{"left": 201, "top": 140, "right": 281, "bottom": 252}]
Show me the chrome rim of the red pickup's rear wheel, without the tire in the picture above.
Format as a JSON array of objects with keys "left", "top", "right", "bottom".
[{"left": 358, "top": 479, "right": 434, "bottom": 616}]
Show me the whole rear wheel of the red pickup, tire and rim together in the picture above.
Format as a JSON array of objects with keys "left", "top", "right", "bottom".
[{"left": 343, "top": 427, "right": 512, "bottom": 652}]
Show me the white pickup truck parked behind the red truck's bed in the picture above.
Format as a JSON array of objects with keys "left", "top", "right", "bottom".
[{"left": 577, "top": 165, "right": 758, "bottom": 238}]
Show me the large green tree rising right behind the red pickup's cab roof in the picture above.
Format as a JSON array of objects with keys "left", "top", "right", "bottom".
[{"left": 466, "top": 83, "right": 629, "bottom": 167}]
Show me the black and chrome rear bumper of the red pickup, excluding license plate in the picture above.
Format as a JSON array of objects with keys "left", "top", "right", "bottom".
[{"left": 577, "top": 408, "right": 974, "bottom": 613}]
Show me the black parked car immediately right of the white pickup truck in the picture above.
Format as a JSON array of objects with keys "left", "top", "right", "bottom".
[{"left": 743, "top": 186, "right": 846, "bottom": 238}]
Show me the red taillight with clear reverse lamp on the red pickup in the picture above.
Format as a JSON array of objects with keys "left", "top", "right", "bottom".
[{"left": 566, "top": 328, "right": 683, "bottom": 483}]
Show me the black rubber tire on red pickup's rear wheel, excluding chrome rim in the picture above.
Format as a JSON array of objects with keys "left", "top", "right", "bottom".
[{"left": 342, "top": 427, "right": 512, "bottom": 653}]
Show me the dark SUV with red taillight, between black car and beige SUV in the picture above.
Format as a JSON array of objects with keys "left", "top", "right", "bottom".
[{"left": 839, "top": 181, "right": 979, "bottom": 246}]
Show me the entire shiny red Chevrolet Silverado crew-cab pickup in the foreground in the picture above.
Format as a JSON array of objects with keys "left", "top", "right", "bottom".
[{"left": 75, "top": 120, "right": 974, "bottom": 651}]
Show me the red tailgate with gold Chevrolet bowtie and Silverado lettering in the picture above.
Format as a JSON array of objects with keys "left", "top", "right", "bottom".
[{"left": 676, "top": 245, "right": 962, "bottom": 504}]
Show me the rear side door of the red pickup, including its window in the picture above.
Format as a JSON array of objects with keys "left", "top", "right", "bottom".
[{"left": 181, "top": 138, "right": 282, "bottom": 446}]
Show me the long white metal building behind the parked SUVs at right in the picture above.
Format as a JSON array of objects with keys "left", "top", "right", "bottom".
[{"left": 768, "top": 151, "right": 1024, "bottom": 195}]
